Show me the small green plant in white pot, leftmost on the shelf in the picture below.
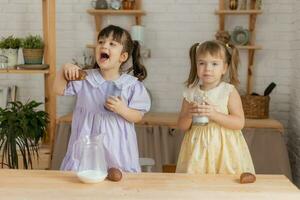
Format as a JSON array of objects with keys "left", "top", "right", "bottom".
[{"left": 0, "top": 35, "right": 21, "bottom": 67}]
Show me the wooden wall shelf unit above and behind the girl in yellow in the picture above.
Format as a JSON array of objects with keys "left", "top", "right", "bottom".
[{"left": 215, "top": 0, "right": 262, "bottom": 94}]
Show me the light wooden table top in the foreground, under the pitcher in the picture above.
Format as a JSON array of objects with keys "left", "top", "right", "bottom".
[{"left": 0, "top": 169, "right": 300, "bottom": 200}]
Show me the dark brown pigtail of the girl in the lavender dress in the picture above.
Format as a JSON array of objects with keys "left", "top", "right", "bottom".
[{"left": 132, "top": 40, "right": 147, "bottom": 81}]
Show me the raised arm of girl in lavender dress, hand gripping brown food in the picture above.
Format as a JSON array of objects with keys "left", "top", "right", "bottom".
[{"left": 53, "top": 64, "right": 80, "bottom": 95}]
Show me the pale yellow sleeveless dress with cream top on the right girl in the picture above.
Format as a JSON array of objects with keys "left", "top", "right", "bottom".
[{"left": 176, "top": 82, "right": 255, "bottom": 174}]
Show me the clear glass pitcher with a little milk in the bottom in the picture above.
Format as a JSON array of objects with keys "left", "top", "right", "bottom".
[{"left": 73, "top": 134, "right": 107, "bottom": 183}]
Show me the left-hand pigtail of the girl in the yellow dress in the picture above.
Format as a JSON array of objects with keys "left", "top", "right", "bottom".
[{"left": 185, "top": 43, "right": 199, "bottom": 87}]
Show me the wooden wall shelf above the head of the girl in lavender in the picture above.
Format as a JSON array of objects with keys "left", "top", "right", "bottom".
[{"left": 87, "top": 0, "right": 146, "bottom": 48}]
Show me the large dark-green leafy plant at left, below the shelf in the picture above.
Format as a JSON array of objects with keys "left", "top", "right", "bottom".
[{"left": 0, "top": 101, "right": 49, "bottom": 169}]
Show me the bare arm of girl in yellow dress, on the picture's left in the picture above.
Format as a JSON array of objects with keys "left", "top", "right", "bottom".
[{"left": 177, "top": 99, "right": 197, "bottom": 132}]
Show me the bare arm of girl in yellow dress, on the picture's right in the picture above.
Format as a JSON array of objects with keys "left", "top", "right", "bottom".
[{"left": 200, "top": 88, "right": 245, "bottom": 130}]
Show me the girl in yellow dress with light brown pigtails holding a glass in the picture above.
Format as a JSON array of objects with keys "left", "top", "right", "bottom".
[{"left": 176, "top": 40, "right": 255, "bottom": 174}]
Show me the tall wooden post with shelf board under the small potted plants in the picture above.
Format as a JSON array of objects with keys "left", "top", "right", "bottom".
[{"left": 0, "top": 0, "right": 56, "bottom": 146}]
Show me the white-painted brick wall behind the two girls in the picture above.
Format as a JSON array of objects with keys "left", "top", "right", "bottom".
[{"left": 0, "top": 0, "right": 300, "bottom": 184}]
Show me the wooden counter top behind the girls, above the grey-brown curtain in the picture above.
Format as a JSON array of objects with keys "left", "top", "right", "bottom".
[{"left": 58, "top": 112, "right": 284, "bottom": 133}]
